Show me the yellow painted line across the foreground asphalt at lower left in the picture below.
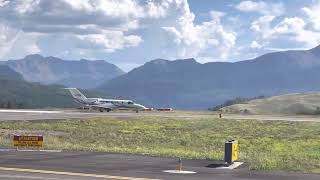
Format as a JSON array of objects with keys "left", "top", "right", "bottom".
[{"left": 0, "top": 167, "right": 160, "bottom": 180}]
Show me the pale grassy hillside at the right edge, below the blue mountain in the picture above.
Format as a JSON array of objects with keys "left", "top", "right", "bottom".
[{"left": 221, "top": 92, "right": 320, "bottom": 114}]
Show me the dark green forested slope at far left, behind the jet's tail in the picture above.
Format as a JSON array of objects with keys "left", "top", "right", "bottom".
[{"left": 0, "top": 65, "right": 109, "bottom": 108}]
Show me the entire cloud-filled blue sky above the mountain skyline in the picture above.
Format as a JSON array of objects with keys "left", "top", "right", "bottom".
[{"left": 0, "top": 0, "right": 320, "bottom": 71}]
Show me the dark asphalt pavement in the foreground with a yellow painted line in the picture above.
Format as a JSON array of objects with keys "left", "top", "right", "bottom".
[{"left": 0, "top": 151, "right": 320, "bottom": 180}]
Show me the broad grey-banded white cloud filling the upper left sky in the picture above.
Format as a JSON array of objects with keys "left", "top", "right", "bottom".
[{"left": 0, "top": 0, "right": 148, "bottom": 57}]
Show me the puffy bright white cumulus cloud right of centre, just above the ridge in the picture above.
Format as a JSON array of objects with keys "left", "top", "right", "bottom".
[{"left": 163, "top": 10, "right": 236, "bottom": 62}]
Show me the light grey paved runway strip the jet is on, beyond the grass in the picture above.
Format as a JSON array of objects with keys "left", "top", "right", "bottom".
[{"left": 0, "top": 109, "right": 320, "bottom": 122}]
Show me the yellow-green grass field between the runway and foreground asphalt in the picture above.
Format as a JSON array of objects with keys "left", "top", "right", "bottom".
[{"left": 0, "top": 116, "right": 320, "bottom": 173}]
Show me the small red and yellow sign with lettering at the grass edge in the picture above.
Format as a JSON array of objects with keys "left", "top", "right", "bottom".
[{"left": 13, "top": 135, "right": 43, "bottom": 150}]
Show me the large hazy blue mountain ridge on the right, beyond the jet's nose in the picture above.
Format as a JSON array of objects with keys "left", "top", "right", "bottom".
[{"left": 99, "top": 46, "right": 320, "bottom": 109}]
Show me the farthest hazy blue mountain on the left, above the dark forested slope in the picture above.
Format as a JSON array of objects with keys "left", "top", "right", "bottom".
[{"left": 1, "top": 54, "right": 124, "bottom": 89}]
